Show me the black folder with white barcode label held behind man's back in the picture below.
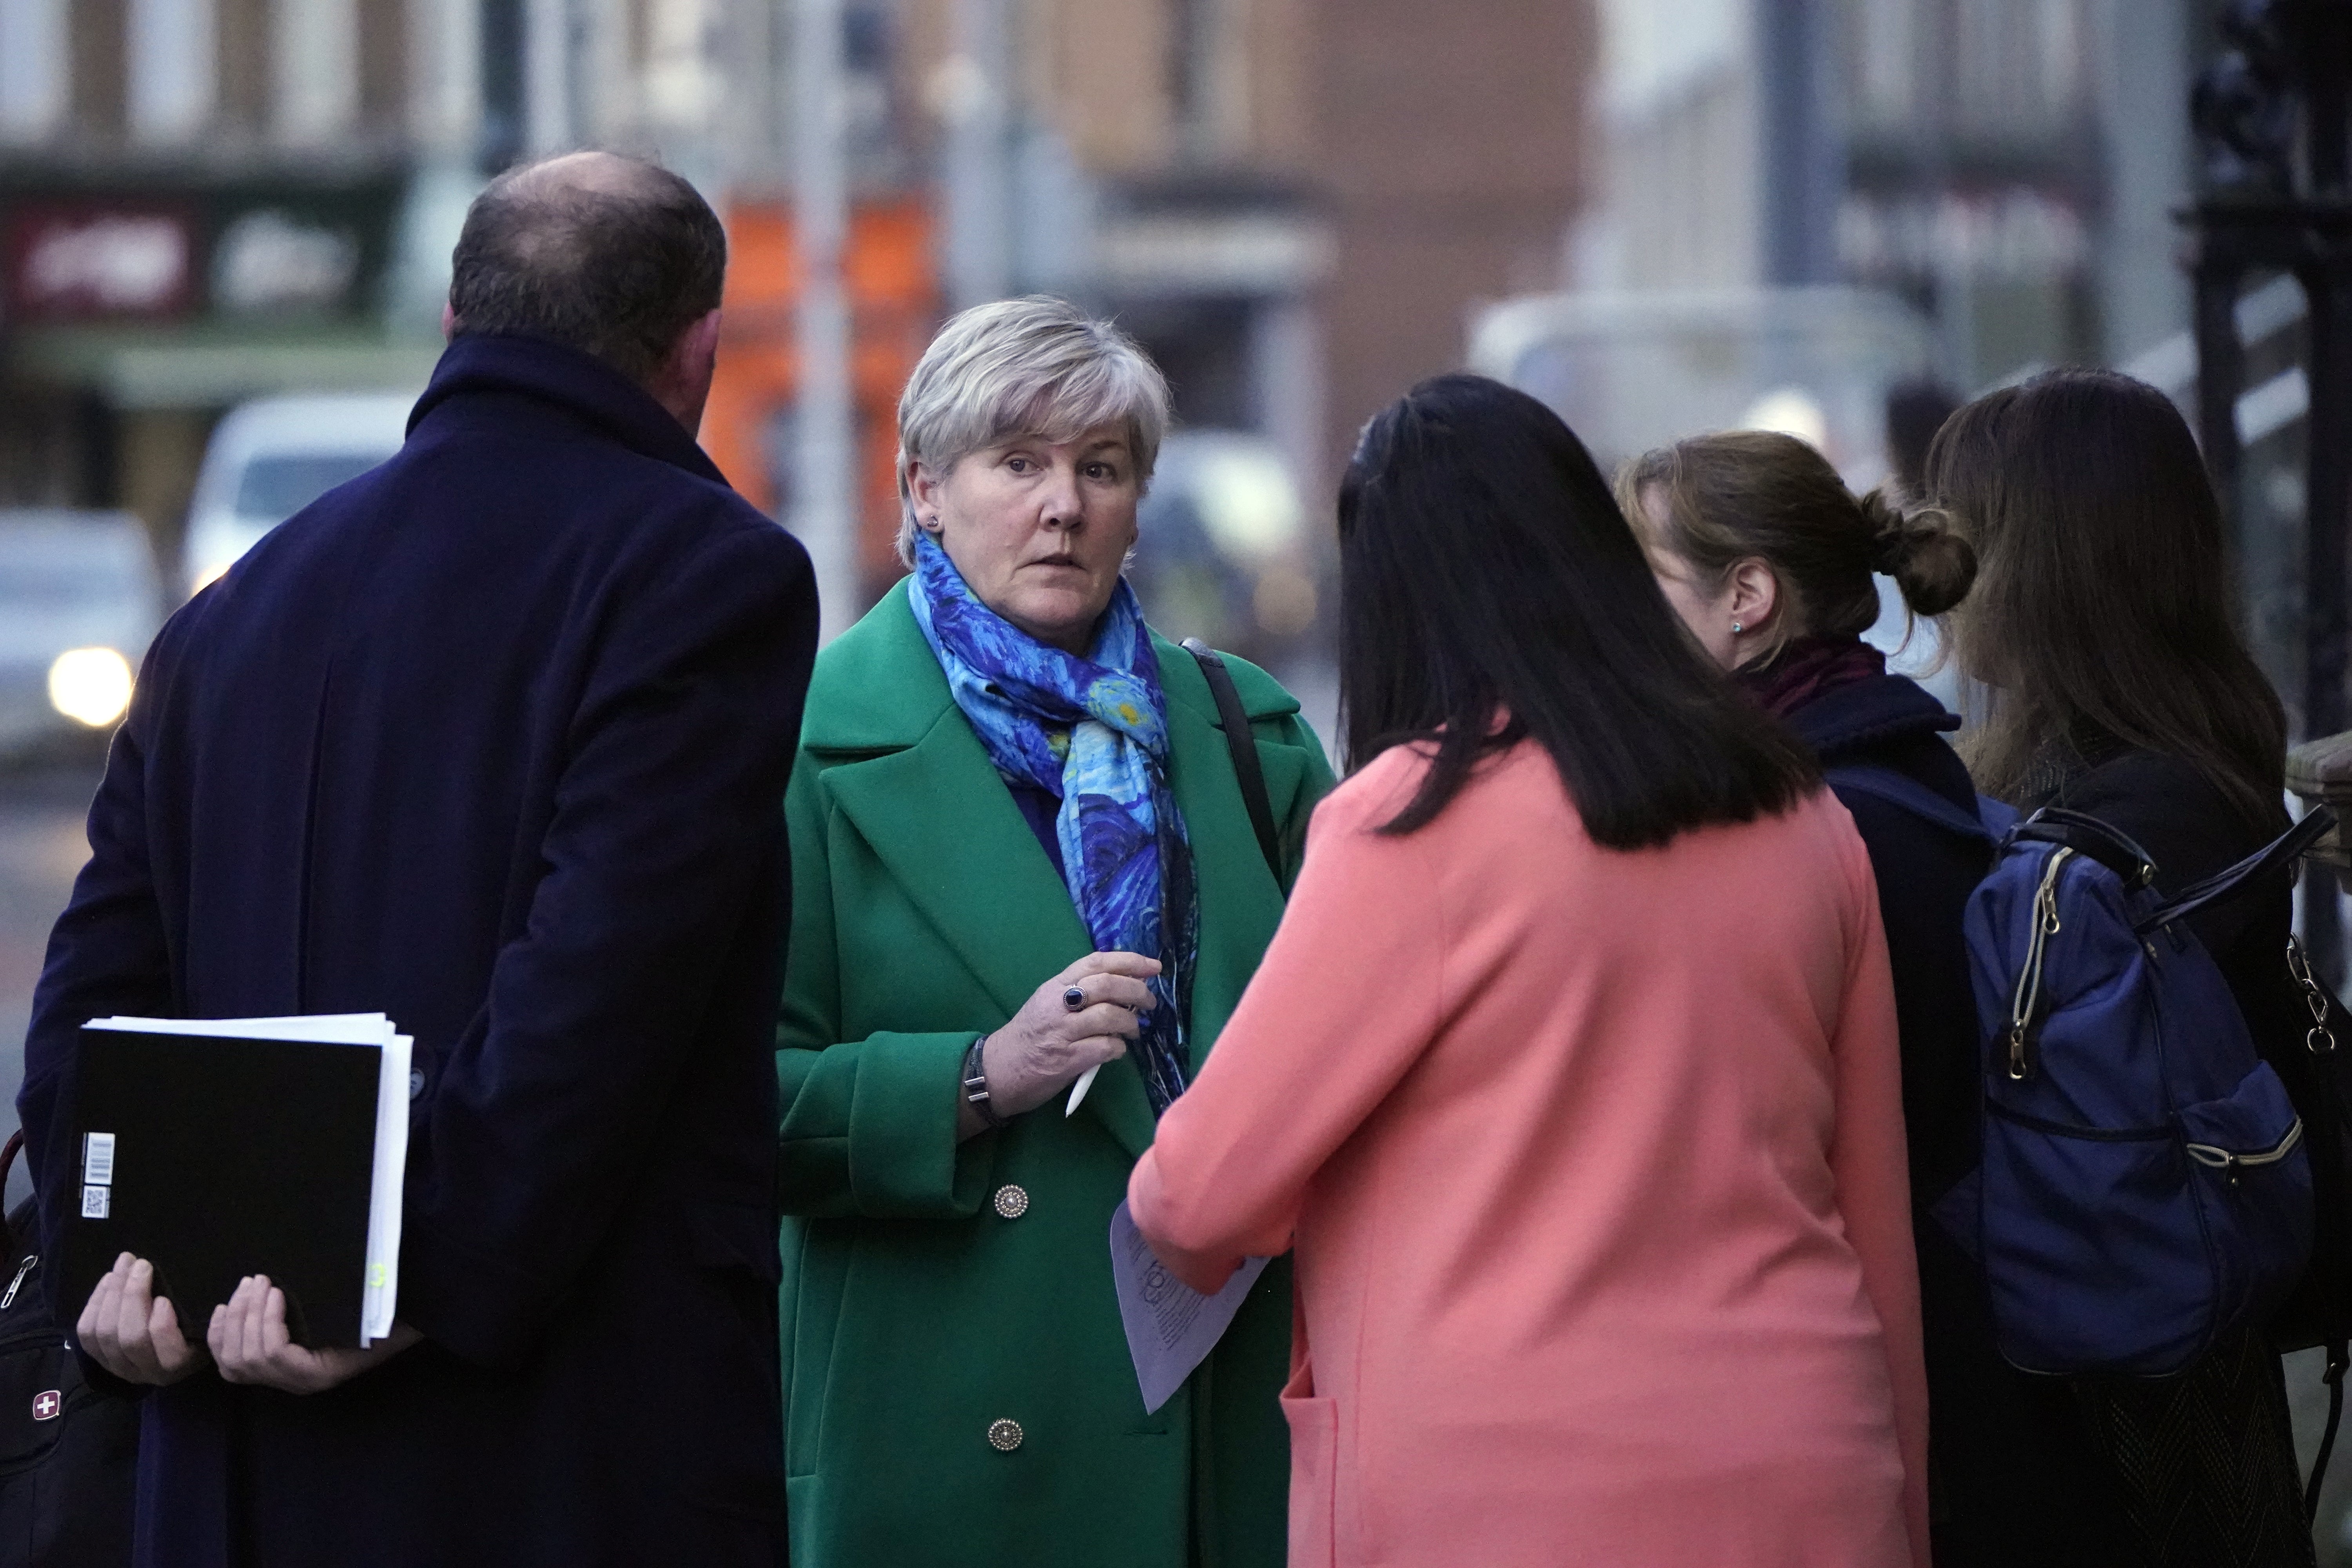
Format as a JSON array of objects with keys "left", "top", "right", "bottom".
[{"left": 64, "top": 1027, "right": 383, "bottom": 1347}]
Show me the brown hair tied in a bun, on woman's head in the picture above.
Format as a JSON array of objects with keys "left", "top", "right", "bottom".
[{"left": 1618, "top": 430, "right": 1976, "bottom": 646}]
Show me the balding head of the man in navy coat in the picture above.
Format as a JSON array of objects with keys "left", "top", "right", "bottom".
[{"left": 449, "top": 153, "right": 727, "bottom": 383}]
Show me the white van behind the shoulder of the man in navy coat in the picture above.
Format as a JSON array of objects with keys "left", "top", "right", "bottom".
[{"left": 181, "top": 392, "right": 416, "bottom": 595}]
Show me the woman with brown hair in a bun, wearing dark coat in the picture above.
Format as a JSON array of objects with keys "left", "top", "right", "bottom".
[{"left": 1618, "top": 430, "right": 2122, "bottom": 1568}]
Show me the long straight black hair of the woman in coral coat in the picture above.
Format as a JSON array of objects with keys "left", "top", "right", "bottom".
[{"left": 1338, "top": 376, "right": 1818, "bottom": 849}]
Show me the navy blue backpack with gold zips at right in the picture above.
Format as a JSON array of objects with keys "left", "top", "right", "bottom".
[{"left": 1830, "top": 766, "right": 2333, "bottom": 1375}]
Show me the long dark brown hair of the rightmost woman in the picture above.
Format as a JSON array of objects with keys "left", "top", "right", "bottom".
[{"left": 1924, "top": 369, "right": 2286, "bottom": 823}]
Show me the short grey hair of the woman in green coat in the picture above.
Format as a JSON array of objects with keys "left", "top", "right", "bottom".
[{"left": 898, "top": 294, "right": 1169, "bottom": 566}]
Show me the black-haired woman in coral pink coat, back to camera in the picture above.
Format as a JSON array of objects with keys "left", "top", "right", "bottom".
[{"left": 1129, "top": 376, "right": 1926, "bottom": 1568}]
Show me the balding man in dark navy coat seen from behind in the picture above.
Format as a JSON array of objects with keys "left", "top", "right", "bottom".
[{"left": 19, "top": 153, "right": 816, "bottom": 1568}]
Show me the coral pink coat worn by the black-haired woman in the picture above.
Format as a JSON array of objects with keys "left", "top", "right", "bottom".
[{"left": 1129, "top": 743, "right": 1926, "bottom": 1568}]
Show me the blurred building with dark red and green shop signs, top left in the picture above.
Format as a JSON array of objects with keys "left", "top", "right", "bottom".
[{"left": 0, "top": 0, "right": 753, "bottom": 571}]
